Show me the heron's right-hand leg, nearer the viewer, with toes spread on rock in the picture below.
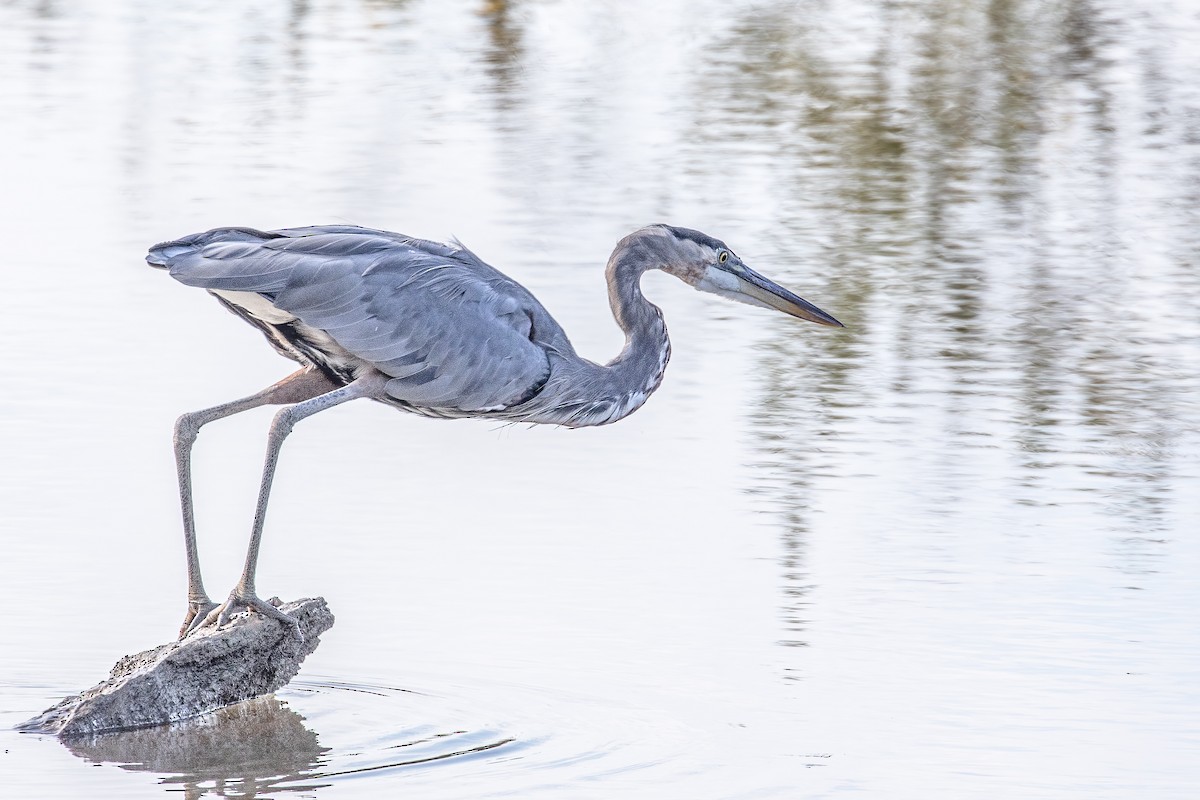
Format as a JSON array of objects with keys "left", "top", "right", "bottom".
[{"left": 193, "top": 373, "right": 386, "bottom": 638}]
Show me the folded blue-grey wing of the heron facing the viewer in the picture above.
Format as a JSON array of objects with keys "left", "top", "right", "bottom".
[{"left": 151, "top": 227, "right": 565, "bottom": 411}]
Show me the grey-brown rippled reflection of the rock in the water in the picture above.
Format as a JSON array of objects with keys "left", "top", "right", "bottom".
[{"left": 64, "top": 696, "right": 329, "bottom": 798}]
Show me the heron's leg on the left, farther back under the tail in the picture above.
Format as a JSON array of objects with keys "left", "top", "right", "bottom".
[{"left": 175, "top": 367, "right": 336, "bottom": 638}]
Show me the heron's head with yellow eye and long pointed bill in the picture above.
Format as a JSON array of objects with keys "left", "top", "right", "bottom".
[{"left": 632, "top": 224, "right": 844, "bottom": 327}]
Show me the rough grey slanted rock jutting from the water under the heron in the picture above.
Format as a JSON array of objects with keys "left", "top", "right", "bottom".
[{"left": 17, "top": 597, "right": 334, "bottom": 736}]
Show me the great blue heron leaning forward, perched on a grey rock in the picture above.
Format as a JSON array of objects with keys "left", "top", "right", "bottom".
[{"left": 146, "top": 224, "right": 841, "bottom": 638}]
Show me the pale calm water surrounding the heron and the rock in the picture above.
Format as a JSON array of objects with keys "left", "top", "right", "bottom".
[{"left": 0, "top": 0, "right": 1200, "bottom": 800}]
